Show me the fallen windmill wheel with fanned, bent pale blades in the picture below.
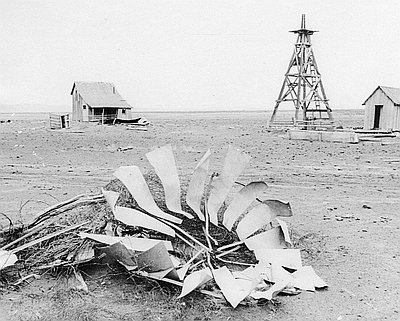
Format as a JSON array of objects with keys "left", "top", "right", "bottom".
[{"left": 0, "top": 145, "right": 326, "bottom": 307}]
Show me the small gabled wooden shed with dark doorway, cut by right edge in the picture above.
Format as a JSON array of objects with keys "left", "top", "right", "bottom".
[{"left": 363, "top": 86, "right": 400, "bottom": 131}]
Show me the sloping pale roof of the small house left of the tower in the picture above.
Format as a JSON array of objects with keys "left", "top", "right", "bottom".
[{"left": 71, "top": 81, "right": 132, "bottom": 108}]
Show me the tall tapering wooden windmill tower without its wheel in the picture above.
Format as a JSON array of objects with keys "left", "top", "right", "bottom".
[{"left": 270, "top": 14, "right": 333, "bottom": 125}]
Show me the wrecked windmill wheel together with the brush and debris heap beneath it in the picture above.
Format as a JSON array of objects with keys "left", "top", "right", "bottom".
[{"left": 0, "top": 145, "right": 327, "bottom": 307}]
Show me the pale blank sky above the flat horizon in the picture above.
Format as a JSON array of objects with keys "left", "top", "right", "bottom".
[{"left": 0, "top": 0, "right": 400, "bottom": 112}]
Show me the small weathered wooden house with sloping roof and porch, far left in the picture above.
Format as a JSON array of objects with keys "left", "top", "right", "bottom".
[{"left": 71, "top": 81, "right": 132, "bottom": 123}]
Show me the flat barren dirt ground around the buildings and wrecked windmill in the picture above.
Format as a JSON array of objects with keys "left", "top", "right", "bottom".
[{"left": 0, "top": 110, "right": 400, "bottom": 320}]
